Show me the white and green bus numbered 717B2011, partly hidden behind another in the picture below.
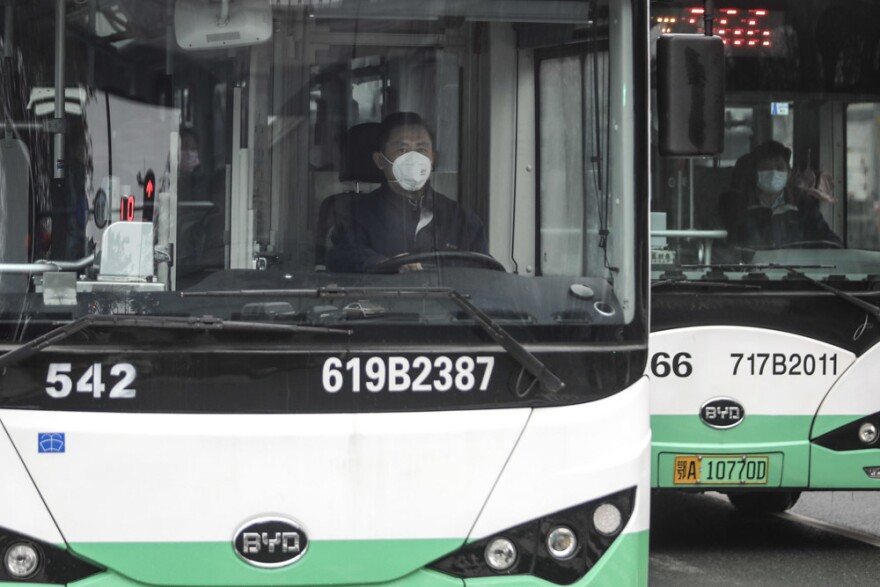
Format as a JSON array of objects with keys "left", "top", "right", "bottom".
[{"left": 648, "top": 0, "right": 880, "bottom": 511}]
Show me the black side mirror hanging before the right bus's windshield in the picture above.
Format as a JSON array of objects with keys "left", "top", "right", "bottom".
[{"left": 657, "top": 35, "right": 724, "bottom": 157}]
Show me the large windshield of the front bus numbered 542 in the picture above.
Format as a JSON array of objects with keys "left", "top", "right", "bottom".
[{"left": 0, "top": 0, "right": 640, "bottom": 350}]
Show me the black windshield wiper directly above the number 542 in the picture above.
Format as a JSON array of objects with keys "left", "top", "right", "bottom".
[{"left": 0, "top": 314, "right": 352, "bottom": 369}]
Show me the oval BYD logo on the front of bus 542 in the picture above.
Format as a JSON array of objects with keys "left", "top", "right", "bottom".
[{"left": 233, "top": 518, "right": 309, "bottom": 568}]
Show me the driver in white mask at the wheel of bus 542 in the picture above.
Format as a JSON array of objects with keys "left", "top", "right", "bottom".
[{"left": 327, "top": 112, "right": 488, "bottom": 272}]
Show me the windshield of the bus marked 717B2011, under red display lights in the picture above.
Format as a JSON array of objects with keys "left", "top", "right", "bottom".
[{"left": 651, "top": 0, "right": 880, "bottom": 291}]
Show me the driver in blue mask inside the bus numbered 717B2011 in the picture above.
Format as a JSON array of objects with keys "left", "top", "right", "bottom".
[{"left": 719, "top": 140, "right": 843, "bottom": 249}]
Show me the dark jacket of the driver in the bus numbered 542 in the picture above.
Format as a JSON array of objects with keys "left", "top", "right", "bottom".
[{"left": 327, "top": 184, "right": 488, "bottom": 272}]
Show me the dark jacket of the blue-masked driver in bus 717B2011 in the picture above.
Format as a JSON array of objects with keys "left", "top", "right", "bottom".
[{"left": 719, "top": 187, "right": 842, "bottom": 248}]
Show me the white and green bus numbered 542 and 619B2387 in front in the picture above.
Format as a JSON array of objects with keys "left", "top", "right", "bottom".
[{"left": 0, "top": 0, "right": 660, "bottom": 587}]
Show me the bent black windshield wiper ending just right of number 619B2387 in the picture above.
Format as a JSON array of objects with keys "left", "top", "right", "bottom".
[{"left": 178, "top": 286, "right": 565, "bottom": 393}]
